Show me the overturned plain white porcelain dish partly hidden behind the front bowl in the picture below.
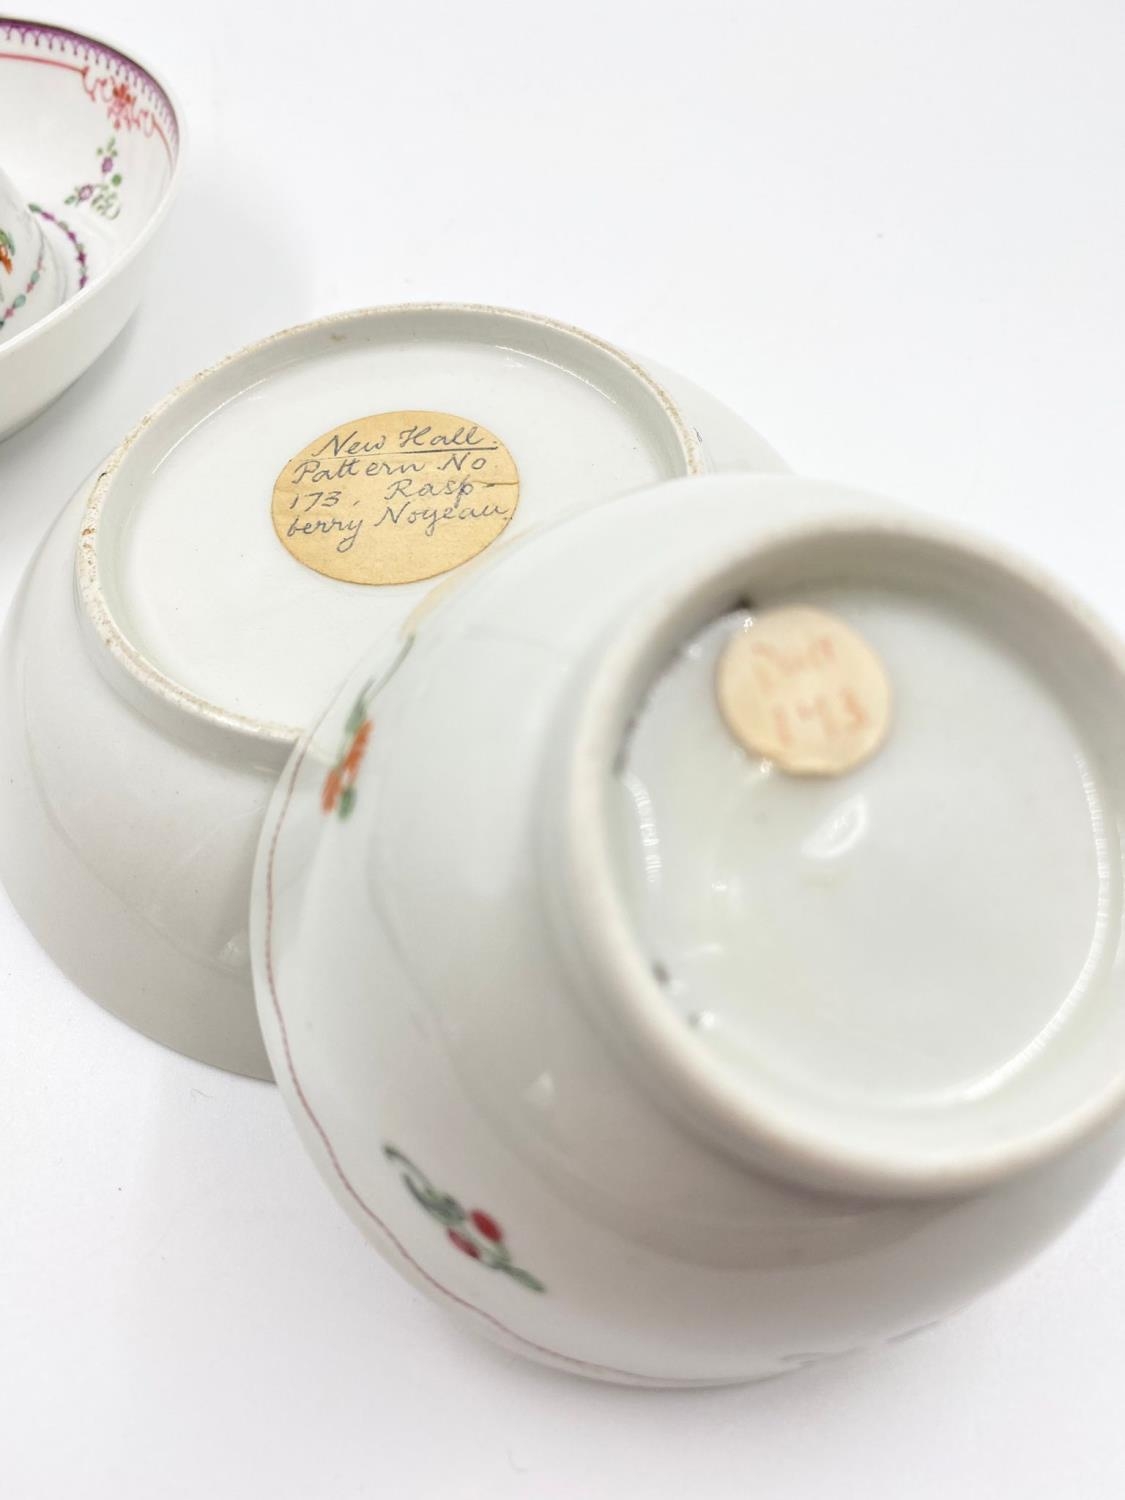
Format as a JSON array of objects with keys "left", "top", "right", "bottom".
[{"left": 0, "top": 308, "right": 780, "bottom": 1076}]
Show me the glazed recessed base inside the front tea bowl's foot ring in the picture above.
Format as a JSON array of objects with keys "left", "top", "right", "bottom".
[{"left": 615, "top": 597, "right": 1121, "bottom": 1133}]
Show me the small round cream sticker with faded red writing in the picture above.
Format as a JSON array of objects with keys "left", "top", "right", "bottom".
[{"left": 716, "top": 606, "right": 891, "bottom": 776}]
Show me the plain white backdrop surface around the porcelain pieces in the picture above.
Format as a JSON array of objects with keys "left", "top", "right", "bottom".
[{"left": 0, "top": 0, "right": 1125, "bottom": 1500}]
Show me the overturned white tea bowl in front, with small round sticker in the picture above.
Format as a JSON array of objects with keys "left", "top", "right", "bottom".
[{"left": 251, "top": 474, "right": 1125, "bottom": 1385}]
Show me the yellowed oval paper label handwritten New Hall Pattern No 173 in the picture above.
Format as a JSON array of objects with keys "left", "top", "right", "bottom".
[{"left": 273, "top": 411, "right": 519, "bottom": 584}]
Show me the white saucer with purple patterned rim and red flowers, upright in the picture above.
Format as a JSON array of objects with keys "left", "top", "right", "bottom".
[{"left": 0, "top": 18, "right": 180, "bottom": 438}]
